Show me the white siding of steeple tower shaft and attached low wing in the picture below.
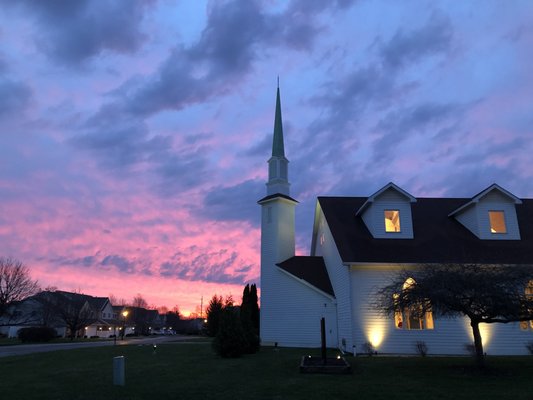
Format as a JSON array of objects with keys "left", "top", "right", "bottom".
[{"left": 260, "top": 198, "right": 337, "bottom": 347}]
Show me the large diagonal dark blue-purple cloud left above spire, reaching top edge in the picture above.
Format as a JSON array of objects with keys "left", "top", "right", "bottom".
[{"left": 123, "top": 0, "right": 347, "bottom": 115}]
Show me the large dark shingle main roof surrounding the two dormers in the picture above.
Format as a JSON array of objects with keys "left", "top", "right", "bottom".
[{"left": 318, "top": 197, "right": 533, "bottom": 264}]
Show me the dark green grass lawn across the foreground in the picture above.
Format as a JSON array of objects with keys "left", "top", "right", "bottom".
[{"left": 0, "top": 343, "right": 533, "bottom": 400}]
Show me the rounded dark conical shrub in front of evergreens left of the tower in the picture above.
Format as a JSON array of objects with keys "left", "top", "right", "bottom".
[{"left": 213, "top": 306, "right": 248, "bottom": 358}]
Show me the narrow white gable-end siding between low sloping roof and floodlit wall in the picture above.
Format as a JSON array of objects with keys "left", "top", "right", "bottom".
[{"left": 314, "top": 204, "right": 353, "bottom": 352}]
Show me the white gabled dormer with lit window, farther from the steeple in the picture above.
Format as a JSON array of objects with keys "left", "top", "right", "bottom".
[{"left": 448, "top": 184, "right": 522, "bottom": 240}]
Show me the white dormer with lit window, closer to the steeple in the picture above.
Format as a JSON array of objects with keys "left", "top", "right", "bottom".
[{"left": 355, "top": 182, "right": 416, "bottom": 239}]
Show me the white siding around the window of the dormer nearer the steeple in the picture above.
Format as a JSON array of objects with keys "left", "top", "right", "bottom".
[{"left": 360, "top": 189, "right": 413, "bottom": 239}]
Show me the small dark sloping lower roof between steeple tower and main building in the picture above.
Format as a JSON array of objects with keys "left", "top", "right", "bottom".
[{"left": 277, "top": 256, "right": 335, "bottom": 296}]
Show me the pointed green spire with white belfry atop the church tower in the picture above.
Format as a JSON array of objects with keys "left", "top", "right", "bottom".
[{"left": 267, "top": 84, "right": 290, "bottom": 196}]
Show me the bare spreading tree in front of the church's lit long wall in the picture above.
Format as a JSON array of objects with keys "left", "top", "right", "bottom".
[{"left": 374, "top": 264, "right": 533, "bottom": 366}]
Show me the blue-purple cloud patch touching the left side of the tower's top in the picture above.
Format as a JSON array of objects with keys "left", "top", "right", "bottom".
[{"left": 202, "top": 180, "right": 266, "bottom": 226}]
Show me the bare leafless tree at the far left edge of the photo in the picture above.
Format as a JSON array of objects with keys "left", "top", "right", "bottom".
[{"left": 0, "top": 257, "right": 39, "bottom": 317}]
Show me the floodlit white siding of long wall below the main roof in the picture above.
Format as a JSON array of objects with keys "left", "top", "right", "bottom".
[{"left": 351, "top": 266, "right": 533, "bottom": 355}]
